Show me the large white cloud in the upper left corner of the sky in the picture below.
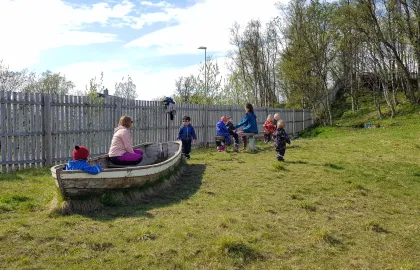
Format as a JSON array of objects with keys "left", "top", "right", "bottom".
[{"left": 0, "top": 0, "right": 134, "bottom": 69}]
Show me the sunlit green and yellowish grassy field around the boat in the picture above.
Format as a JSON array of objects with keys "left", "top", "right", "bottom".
[{"left": 0, "top": 109, "right": 420, "bottom": 269}]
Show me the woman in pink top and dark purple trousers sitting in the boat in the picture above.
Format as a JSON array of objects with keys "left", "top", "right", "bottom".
[{"left": 108, "top": 116, "right": 143, "bottom": 166}]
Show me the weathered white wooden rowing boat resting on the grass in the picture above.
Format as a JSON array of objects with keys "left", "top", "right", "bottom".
[{"left": 51, "top": 141, "right": 184, "bottom": 200}]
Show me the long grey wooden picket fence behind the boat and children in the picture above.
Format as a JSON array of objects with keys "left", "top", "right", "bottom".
[{"left": 0, "top": 91, "right": 312, "bottom": 173}]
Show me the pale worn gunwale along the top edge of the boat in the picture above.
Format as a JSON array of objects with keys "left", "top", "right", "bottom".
[{"left": 51, "top": 141, "right": 182, "bottom": 178}]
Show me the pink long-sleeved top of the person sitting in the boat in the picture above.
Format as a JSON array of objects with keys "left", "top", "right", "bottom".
[{"left": 108, "top": 126, "right": 134, "bottom": 157}]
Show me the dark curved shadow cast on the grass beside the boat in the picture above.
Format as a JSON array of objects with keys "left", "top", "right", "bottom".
[{"left": 84, "top": 164, "right": 206, "bottom": 221}]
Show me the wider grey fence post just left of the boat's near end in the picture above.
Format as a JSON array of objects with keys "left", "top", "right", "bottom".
[{"left": 42, "top": 94, "right": 53, "bottom": 166}]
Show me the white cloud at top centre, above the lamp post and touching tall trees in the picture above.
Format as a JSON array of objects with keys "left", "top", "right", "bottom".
[{"left": 126, "top": 0, "right": 278, "bottom": 55}]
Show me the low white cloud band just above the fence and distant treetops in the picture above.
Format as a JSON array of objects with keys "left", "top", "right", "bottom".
[{"left": 55, "top": 58, "right": 227, "bottom": 100}]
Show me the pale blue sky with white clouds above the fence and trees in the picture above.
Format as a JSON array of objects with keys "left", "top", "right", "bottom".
[{"left": 0, "top": 0, "right": 278, "bottom": 100}]
